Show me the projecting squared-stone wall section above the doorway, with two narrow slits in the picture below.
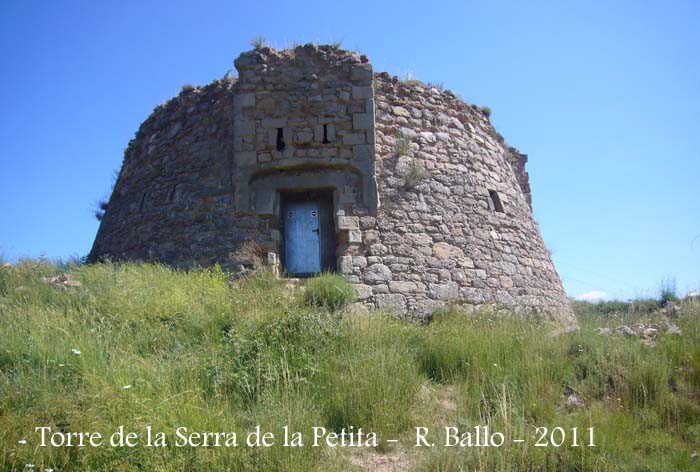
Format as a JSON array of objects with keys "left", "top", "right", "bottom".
[{"left": 234, "top": 44, "right": 377, "bottom": 216}]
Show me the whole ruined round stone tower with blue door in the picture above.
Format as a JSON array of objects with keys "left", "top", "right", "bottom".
[{"left": 90, "top": 45, "right": 575, "bottom": 328}]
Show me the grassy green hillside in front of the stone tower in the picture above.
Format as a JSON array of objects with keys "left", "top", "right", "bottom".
[{"left": 0, "top": 261, "right": 700, "bottom": 471}]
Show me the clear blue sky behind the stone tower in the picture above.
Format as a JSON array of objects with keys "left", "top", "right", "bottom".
[{"left": 0, "top": 0, "right": 700, "bottom": 299}]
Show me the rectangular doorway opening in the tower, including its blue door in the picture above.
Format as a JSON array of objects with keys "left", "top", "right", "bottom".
[{"left": 280, "top": 190, "right": 336, "bottom": 277}]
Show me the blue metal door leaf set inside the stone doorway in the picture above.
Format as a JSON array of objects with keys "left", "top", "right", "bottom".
[{"left": 284, "top": 200, "right": 321, "bottom": 275}]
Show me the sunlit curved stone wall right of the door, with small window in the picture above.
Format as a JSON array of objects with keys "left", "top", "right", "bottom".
[{"left": 341, "top": 74, "right": 575, "bottom": 328}]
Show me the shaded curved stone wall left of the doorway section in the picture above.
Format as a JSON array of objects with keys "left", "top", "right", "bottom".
[{"left": 90, "top": 80, "right": 259, "bottom": 266}]
